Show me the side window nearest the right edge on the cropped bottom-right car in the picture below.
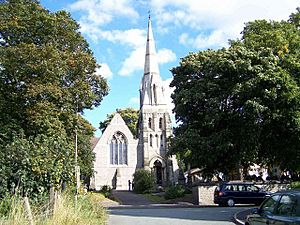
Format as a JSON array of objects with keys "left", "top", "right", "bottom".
[{"left": 276, "top": 195, "right": 299, "bottom": 216}]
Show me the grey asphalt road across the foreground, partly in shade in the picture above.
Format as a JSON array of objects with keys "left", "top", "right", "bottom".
[{"left": 108, "top": 207, "right": 246, "bottom": 225}]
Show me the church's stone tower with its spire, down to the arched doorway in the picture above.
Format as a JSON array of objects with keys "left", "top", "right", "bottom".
[{"left": 138, "top": 16, "right": 177, "bottom": 185}]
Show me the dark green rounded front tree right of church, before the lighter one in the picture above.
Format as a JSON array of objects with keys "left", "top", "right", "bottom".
[{"left": 171, "top": 46, "right": 299, "bottom": 176}]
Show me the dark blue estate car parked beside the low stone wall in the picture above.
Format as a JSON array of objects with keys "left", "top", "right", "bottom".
[{"left": 214, "top": 182, "right": 270, "bottom": 207}]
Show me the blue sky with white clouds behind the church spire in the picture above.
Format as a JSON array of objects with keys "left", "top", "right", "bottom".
[{"left": 41, "top": 0, "right": 300, "bottom": 137}]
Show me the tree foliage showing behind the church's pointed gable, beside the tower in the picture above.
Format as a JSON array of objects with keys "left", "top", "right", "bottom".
[{"left": 99, "top": 108, "right": 139, "bottom": 137}]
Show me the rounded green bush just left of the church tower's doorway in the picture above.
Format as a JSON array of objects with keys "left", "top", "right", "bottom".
[{"left": 133, "top": 169, "right": 154, "bottom": 193}]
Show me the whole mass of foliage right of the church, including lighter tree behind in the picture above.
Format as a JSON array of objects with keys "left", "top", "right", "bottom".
[{"left": 170, "top": 9, "right": 300, "bottom": 176}]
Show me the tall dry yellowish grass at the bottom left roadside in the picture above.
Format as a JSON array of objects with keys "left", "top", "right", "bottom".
[{"left": 0, "top": 193, "right": 107, "bottom": 225}]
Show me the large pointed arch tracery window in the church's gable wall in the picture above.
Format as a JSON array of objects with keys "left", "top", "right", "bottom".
[{"left": 110, "top": 132, "right": 127, "bottom": 165}]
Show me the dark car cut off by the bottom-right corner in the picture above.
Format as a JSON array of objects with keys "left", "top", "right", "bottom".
[{"left": 245, "top": 190, "right": 300, "bottom": 225}]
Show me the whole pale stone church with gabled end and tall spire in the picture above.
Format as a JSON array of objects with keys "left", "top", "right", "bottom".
[{"left": 90, "top": 17, "right": 178, "bottom": 190}]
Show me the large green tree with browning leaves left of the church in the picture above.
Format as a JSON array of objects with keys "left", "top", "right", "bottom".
[{"left": 0, "top": 0, "right": 108, "bottom": 195}]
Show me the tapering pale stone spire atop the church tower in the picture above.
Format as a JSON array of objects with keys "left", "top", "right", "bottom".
[{"left": 140, "top": 15, "right": 165, "bottom": 107}]
